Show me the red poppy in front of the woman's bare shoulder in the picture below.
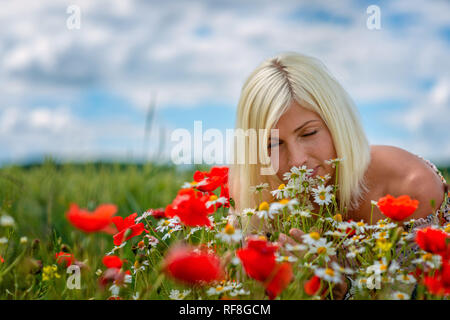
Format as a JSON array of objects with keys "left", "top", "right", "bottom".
[{"left": 377, "top": 194, "right": 419, "bottom": 221}]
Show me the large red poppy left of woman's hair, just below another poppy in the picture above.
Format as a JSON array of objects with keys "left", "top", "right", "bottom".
[{"left": 166, "top": 188, "right": 215, "bottom": 227}]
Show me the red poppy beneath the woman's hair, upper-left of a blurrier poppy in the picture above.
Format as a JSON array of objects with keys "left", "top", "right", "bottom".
[{"left": 236, "top": 238, "right": 278, "bottom": 282}]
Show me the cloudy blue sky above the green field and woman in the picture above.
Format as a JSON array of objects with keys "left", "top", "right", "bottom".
[{"left": 0, "top": 0, "right": 450, "bottom": 165}]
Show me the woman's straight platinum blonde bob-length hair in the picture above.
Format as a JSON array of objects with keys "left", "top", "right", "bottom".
[{"left": 230, "top": 53, "right": 370, "bottom": 229}]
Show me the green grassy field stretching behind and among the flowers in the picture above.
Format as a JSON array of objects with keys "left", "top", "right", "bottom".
[{"left": 0, "top": 159, "right": 450, "bottom": 299}]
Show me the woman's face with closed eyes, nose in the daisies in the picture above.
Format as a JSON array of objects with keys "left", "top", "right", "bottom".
[{"left": 269, "top": 102, "right": 337, "bottom": 180}]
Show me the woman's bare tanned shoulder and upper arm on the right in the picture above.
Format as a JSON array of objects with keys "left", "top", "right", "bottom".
[{"left": 369, "top": 145, "right": 444, "bottom": 218}]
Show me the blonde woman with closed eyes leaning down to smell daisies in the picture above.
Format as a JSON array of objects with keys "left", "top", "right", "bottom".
[{"left": 230, "top": 53, "right": 450, "bottom": 298}]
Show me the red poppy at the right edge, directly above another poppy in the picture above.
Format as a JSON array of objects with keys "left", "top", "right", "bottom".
[{"left": 416, "top": 227, "right": 450, "bottom": 256}]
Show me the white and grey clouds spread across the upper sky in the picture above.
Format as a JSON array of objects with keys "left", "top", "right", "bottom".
[{"left": 0, "top": 0, "right": 450, "bottom": 164}]
